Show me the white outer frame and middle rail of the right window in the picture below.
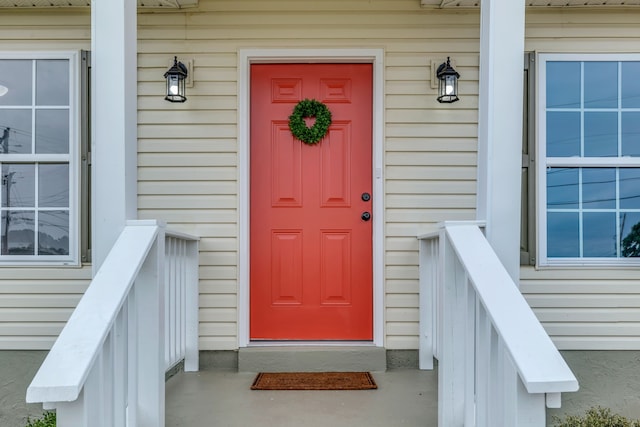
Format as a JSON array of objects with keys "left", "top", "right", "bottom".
[{"left": 536, "top": 53, "right": 640, "bottom": 267}]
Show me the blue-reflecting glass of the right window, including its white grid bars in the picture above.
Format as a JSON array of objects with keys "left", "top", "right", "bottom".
[{"left": 538, "top": 54, "right": 640, "bottom": 264}]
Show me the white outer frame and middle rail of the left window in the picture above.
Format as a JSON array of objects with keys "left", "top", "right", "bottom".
[{"left": 0, "top": 51, "right": 82, "bottom": 267}]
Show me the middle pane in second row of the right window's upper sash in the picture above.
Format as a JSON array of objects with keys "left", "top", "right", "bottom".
[{"left": 584, "top": 113, "right": 618, "bottom": 157}]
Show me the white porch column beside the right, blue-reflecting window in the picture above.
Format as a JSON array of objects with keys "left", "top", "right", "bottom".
[{"left": 477, "top": 0, "right": 525, "bottom": 283}]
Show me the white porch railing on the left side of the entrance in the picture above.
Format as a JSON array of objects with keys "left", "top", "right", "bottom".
[{"left": 27, "top": 221, "right": 198, "bottom": 427}]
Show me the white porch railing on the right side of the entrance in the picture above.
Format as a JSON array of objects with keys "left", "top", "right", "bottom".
[{"left": 418, "top": 222, "right": 578, "bottom": 427}]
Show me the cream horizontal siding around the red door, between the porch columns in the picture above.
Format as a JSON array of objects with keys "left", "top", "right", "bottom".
[{"left": 138, "top": 0, "right": 478, "bottom": 349}]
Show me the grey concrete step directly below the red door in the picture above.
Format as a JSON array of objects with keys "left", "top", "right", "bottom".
[{"left": 238, "top": 346, "right": 387, "bottom": 372}]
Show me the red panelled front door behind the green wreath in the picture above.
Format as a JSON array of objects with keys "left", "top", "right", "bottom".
[{"left": 250, "top": 64, "right": 373, "bottom": 340}]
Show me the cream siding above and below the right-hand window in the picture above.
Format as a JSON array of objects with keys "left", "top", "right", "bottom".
[{"left": 521, "top": 10, "right": 640, "bottom": 350}]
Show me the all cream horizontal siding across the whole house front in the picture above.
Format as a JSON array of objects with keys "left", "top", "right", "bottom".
[{"left": 0, "top": 0, "right": 640, "bottom": 350}]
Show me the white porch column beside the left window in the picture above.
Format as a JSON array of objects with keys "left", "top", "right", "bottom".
[{"left": 91, "top": 0, "right": 137, "bottom": 275}]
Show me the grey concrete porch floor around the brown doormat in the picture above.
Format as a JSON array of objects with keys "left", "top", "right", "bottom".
[{"left": 165, "top": 369, "right": 438, "bottom": 427}]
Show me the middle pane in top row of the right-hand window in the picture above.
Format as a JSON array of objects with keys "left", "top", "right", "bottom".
[{"left": 584, "top": 62, "right": 618, "bottom": 108}]
